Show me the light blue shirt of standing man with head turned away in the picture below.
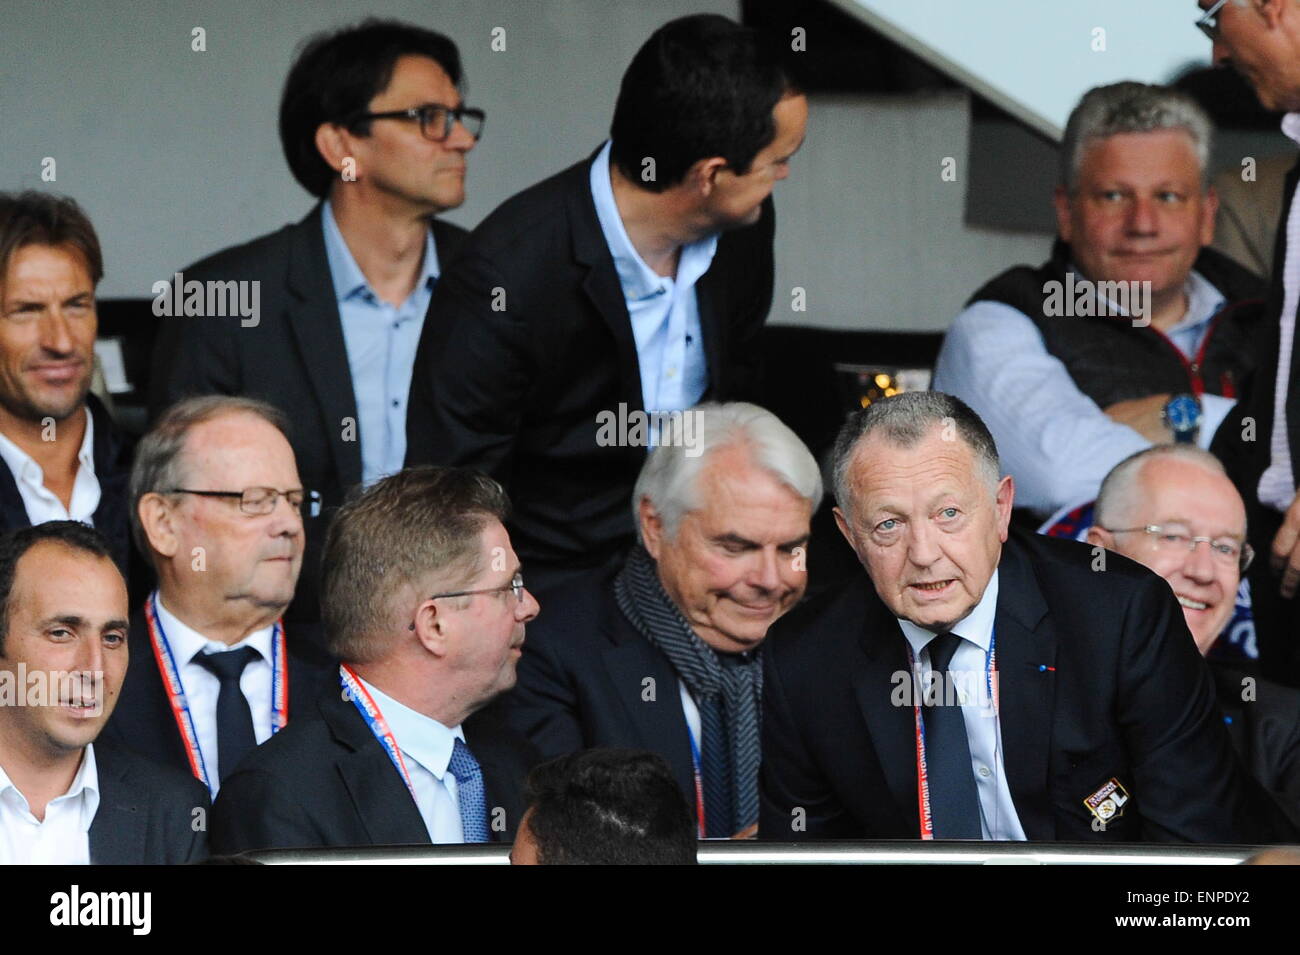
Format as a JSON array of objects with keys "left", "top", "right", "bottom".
[{"left": 592, "top": 142, "right": 718, "bottom": 415}]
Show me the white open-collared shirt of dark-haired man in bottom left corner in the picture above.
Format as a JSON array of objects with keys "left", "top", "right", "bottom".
[{"left": 0, "top": 746, "right": 99, "bottom": 865}]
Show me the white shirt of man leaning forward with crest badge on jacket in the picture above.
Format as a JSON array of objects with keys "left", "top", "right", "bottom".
[{"left": 898, "top": 570, "right": 1024, "bottom": 841}]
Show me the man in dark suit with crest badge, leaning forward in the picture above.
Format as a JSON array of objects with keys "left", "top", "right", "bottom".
[{"left": 759, "top": 392, "right": 1282, "bottom": 842}]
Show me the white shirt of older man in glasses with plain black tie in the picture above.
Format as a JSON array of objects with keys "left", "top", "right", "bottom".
[{"left": 157, "top": 595, "right": 276, "bottom": 798}]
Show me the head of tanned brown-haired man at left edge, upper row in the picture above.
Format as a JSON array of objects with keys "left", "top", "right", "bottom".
[{"left": 0, "top": 192, "right": 104, "bottom": 422}]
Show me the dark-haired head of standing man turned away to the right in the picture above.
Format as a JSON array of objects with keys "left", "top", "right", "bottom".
[{"left": 610, "top": 14, "right": 807, "bottom": 231}]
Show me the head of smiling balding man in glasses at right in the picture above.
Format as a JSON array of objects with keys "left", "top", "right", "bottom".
[{"left": 1088, "top": 444, "right": 1251, "bottom": 654}]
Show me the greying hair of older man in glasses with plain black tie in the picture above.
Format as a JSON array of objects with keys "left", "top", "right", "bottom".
[{"left": 130, "top": 395, "right": 289, "bottom": 557}]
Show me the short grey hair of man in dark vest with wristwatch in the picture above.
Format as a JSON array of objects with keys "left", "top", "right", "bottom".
[{"left": 1060, "top": 82, "right": 1213, "bottom": 192}]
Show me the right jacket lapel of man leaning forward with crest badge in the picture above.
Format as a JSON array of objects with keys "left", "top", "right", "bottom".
[{"left": 995, "top": 538, "right": 1057, "bottom": 839}]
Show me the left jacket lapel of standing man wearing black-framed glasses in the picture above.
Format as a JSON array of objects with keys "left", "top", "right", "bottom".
[{"left": 287, "top": 205, "right": 361, "bottom": 487}]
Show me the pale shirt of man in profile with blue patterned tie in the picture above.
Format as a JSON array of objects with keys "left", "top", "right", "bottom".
[{"left": 358, "top": 677, "right": 467, "bottom": 842}]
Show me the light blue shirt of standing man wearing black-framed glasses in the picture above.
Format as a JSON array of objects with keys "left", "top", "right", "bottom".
[{"left": 321, "top": 201, "right": 438, "bottom": 485}]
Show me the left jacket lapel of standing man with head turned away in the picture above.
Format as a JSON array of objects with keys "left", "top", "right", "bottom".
[{"left": 567, "top": 151, "right": 645, "bottom": 411}]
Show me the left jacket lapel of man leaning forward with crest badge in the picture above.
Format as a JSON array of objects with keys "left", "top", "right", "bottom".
[{"left": 850, "top": 597, "right": 920, "bottom": 837}]
